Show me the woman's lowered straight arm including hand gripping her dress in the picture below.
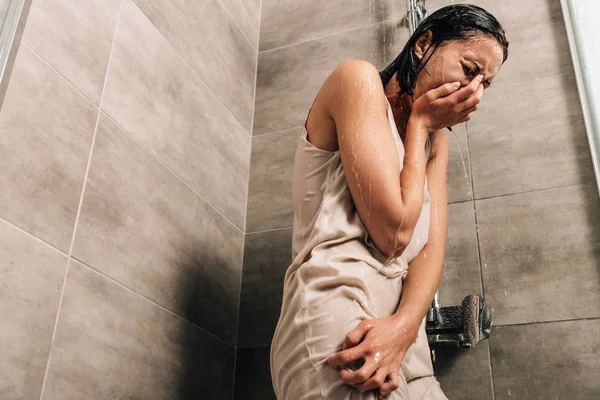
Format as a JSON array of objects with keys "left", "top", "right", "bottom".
[{"left": 328, "top": 131, "right": 448, "bottom": 394}]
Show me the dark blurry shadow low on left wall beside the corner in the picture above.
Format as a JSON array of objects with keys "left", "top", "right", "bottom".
[{"left": 170, "top": 244, "right": 239, "bottom": 400}]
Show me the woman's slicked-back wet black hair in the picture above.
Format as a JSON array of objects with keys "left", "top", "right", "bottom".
[{"left": 379, "top": 4, "right": 508, "bottom": 95}]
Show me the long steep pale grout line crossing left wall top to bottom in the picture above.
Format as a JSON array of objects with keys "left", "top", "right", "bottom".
[{"left": 40, "top": 0, "right": 123, "bottom": 400}]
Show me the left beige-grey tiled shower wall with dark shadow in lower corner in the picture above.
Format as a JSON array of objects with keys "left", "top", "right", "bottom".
[{"left": 0, "top": 0, "right": 260, "bottom": 400}]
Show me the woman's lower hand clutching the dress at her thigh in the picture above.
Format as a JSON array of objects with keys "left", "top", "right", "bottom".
[{"left": 327, "top": 313, "right": 420, "bottom": 394}]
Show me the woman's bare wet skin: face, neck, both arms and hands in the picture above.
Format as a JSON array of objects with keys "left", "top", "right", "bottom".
[{"left": 298, "top": 33, "right": 503, "bottom": 393}]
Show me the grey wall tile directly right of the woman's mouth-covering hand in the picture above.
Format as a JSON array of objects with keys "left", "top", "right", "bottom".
[{"left": 468, "top": 74, "right": 592, "bottom": 198}]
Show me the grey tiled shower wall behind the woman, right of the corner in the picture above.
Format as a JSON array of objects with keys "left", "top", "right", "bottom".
[{"left": 235, "top": 0, "right": 600, "bottom": 400}]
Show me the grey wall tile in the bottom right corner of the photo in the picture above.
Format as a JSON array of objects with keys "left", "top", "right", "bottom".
[{"left": 490, "top": 320, "right": 600, "bottom": 400}]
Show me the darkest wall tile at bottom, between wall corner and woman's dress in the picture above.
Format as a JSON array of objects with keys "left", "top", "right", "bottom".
[{"left": 233, "top": 347, "right": 276, "bottom": 400}]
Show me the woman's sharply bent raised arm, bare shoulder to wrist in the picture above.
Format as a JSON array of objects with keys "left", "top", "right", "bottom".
[{"left": 322, "top": 60, "right": 457, "bottom": 257}]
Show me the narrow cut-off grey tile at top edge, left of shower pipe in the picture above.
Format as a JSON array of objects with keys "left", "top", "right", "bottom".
[{"left": 260, "top": 0, "right": 406, "bottom": 51}]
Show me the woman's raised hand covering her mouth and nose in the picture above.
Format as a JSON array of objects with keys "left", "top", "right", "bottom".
[{"left": 409, "top": 75, "right": 483, "bottom": 133}]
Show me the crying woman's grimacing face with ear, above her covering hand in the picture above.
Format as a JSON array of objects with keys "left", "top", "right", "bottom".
[{"left": 414, "top": 32, "right": 503, "bottom": 100}]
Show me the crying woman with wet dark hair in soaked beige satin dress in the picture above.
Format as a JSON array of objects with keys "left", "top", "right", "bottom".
[{"left": 271, "top": 5, "right": 508, "bottom": 400}]
